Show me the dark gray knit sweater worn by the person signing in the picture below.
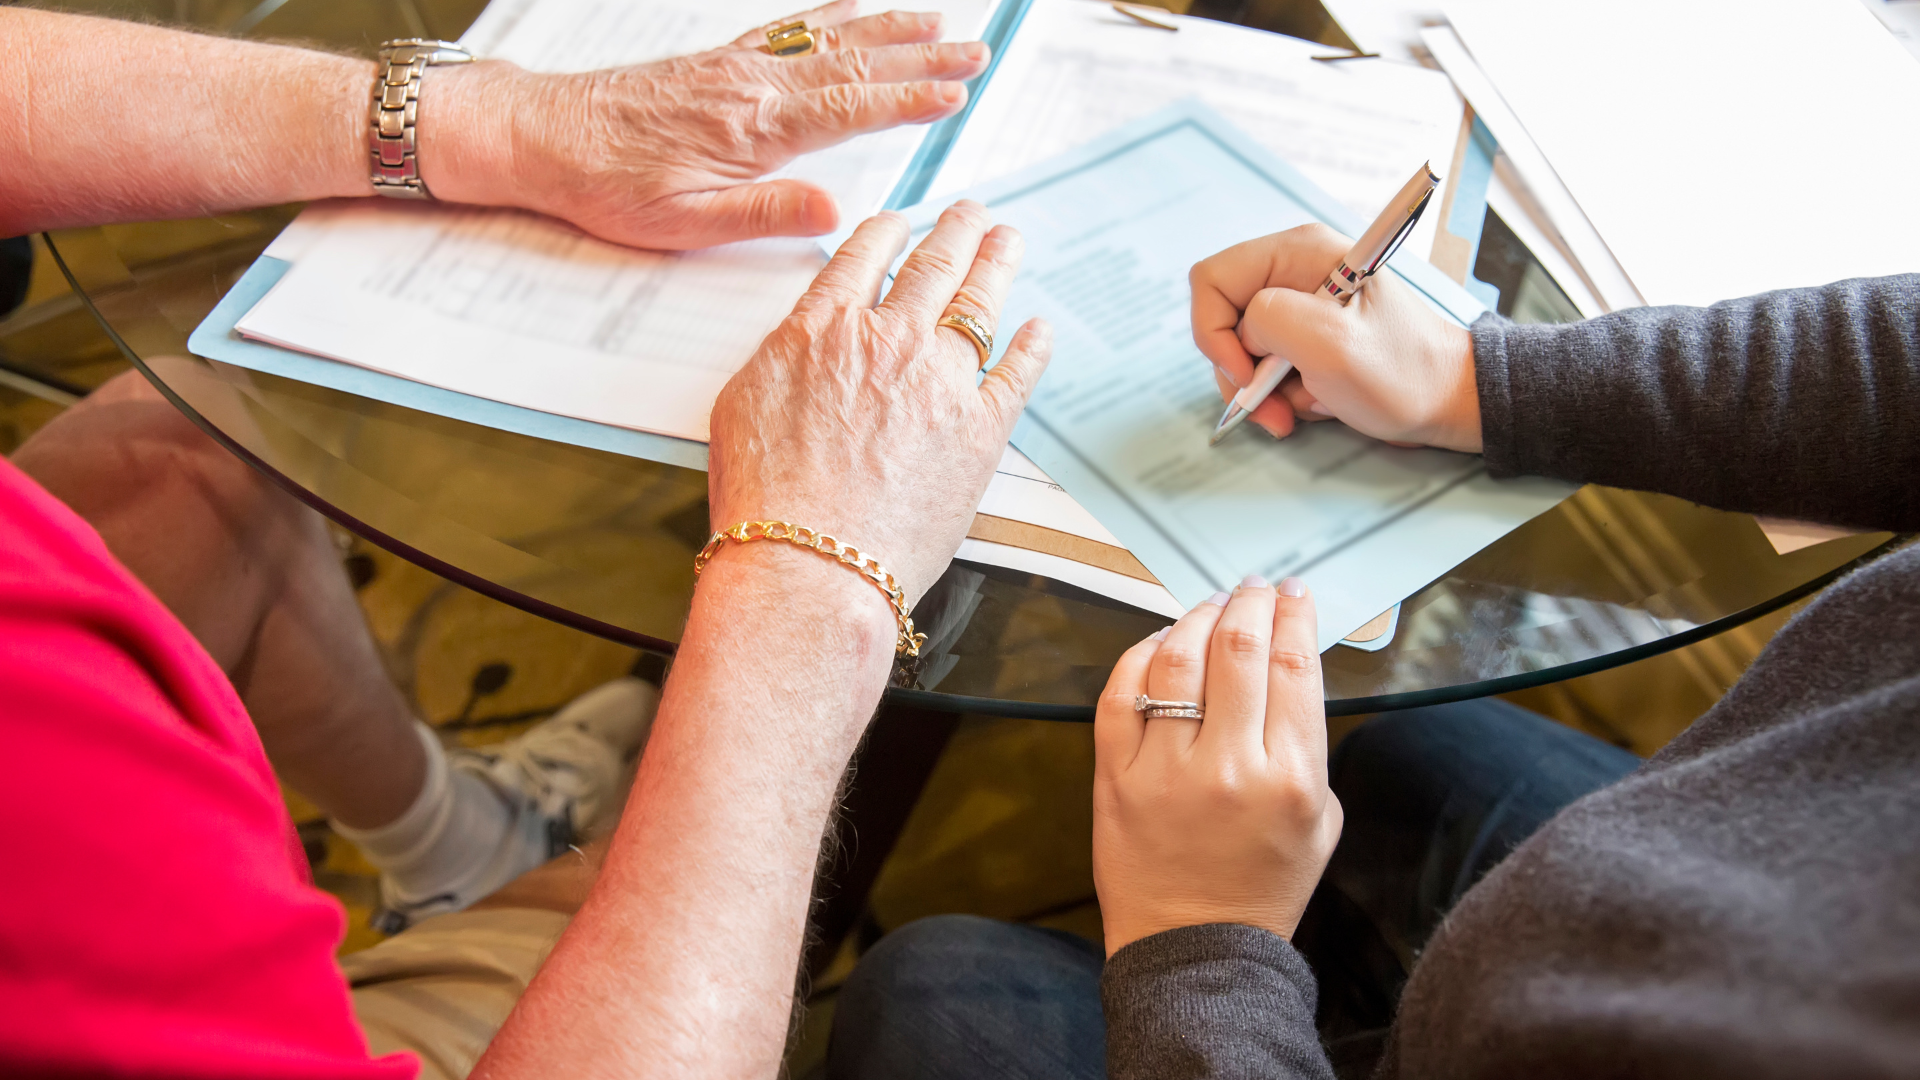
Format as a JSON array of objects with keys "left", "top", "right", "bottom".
[{"left": 1102, "top": 275, "right": 1920, "bottom": 1080}]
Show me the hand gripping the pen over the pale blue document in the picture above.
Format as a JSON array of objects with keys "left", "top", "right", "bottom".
[{"left": 1188, "top": 225, "right": 1480, "bottom": 452}]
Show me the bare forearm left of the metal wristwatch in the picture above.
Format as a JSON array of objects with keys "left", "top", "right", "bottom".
[{"left": 0, "top": 8, "right": 372, "bottom": 236}]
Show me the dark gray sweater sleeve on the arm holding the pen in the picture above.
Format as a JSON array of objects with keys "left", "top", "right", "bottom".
[{"left": 1473, "top": 275, "right": 1920, "bottom": 530}]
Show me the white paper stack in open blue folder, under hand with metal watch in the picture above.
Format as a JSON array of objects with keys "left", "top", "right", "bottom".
[{"left": 238, "top": 0, "right": 991, "bottom": 442}]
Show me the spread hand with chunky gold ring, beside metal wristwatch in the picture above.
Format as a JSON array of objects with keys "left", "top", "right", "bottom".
[{"left": 433, "top": 0, "right": 987, "bottom": 250}]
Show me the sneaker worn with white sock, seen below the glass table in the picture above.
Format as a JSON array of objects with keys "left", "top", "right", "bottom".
[{"left": 372, "top": 676, "right": 660, "bottom": 934}]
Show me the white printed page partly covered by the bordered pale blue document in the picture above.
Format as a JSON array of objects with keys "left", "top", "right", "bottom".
[{"left": 927, "top": 0, "right": 1461, "bottom": 261}]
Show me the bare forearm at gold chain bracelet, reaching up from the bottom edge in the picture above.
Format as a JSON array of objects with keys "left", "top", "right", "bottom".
[{"left": 474, "top": 542, "right": 895, "bottom": 1078}]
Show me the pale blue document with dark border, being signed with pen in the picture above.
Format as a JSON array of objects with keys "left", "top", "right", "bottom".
[{"left": 910, "top": 104, "right": 1572, "bottom": 650}]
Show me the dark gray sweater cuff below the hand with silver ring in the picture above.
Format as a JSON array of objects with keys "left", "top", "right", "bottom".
[{"left": 1100, "top": 922, "right": 1332, "bottom": 1080}]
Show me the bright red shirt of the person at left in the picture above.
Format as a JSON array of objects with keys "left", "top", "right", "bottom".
[{"left": 0, "top": 459, "right": 417, "bottom": 1080}]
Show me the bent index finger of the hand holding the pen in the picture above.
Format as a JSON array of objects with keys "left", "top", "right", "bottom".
[{"left": 1187, "top": 225, "right": 1348, "bottom": 386}]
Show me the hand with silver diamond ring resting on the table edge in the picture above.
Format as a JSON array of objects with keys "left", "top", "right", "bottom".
[{"left": 1092, "top": 578, "right": 1342, "bottom": 955}]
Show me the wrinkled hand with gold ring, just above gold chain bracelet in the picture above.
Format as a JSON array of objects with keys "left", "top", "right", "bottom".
[{"left": 708, "top": 202, "right": 1052, "bottom": 601}]
